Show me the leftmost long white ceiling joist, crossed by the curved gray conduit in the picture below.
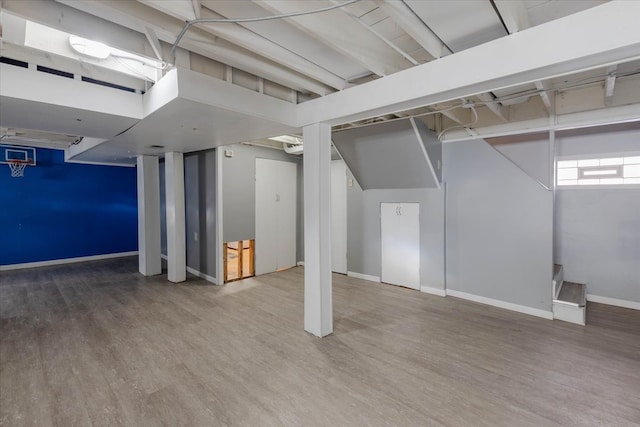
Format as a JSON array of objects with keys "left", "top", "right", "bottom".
[{"left": 57, "top": 0, "right": 332, "bottom": 95}]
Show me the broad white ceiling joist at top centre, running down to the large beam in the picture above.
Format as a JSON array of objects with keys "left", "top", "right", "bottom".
[{"left": 256, "top": 0, "right": 411, "bottom": 76}]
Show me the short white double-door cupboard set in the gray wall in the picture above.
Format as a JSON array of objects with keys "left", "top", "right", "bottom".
[{"left": 380, "top": 203, "right": 420, "bottom": 289}]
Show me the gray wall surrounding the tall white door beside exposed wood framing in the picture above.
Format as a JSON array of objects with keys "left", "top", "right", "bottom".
[{"left": 220, "top": 144, "right": 304, "bottom": 261}]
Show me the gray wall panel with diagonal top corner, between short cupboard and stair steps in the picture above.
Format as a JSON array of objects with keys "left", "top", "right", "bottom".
[{"left": 443, "top": 140, "right": 553, "bottom": 311}]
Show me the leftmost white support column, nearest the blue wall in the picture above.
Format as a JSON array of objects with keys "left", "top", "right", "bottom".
[{"left": 137, "top": 156, "right": 162, "bottom": 276}]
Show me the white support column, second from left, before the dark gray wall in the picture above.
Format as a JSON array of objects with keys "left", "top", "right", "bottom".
[{"left": 164, "top": 153, "right": 187, "bottom": 283}]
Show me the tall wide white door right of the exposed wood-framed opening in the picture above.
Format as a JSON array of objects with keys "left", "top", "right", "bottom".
[{"left": 255, "top": 159, "right": 297, "bottom": 275}]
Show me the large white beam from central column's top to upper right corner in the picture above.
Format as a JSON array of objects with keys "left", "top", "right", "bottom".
[{"left": 298, "top": 2, "right": 640, "bottom": 126}]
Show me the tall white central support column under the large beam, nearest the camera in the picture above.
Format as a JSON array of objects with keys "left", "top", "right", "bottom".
[{"left": 303, "top": 123, "right": 333, "bottom": 337}]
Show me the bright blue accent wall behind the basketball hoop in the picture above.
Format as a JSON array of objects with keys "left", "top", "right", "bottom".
[{"left": 0, "top": 149, "right": 138, "bottom": 265}]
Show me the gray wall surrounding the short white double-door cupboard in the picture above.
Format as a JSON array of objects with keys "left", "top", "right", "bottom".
[{"left": 347, "top": 171, "right": 445, "bottom": 289}]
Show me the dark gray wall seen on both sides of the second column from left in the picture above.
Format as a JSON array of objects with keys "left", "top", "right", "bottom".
[{"left": 160, "top": 150, "right": 217, "bottom": 277}]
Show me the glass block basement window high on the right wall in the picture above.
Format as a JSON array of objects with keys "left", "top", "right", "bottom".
[{"left": 556, "top": 156, "right": 640, "bottom": 186}]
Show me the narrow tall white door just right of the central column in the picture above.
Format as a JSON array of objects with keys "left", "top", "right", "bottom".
[{"left": 331, "top": 160, "right": 347, "bottom": 274}]
